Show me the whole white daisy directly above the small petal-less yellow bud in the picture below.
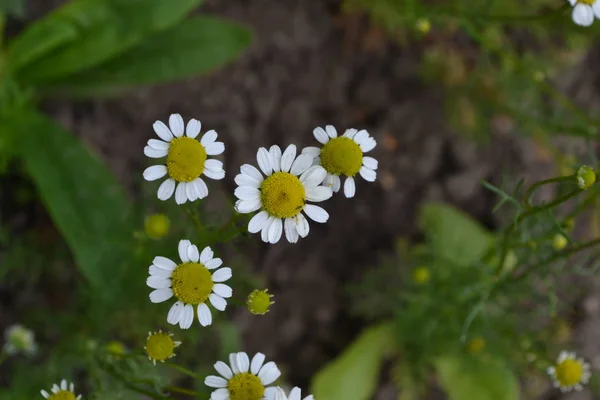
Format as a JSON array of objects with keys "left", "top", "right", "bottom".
[{"left": 146, "top": 240, "right": 232, "bottom": 329}]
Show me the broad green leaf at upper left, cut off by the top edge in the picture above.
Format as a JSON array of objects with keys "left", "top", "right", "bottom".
[{"left": 13, "top": 0, "right": 201, "bottom": 83}]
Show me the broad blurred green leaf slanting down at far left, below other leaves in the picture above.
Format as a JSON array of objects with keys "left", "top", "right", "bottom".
[{"left": 2, "top": 111, "right": 132, "bottom": 296}]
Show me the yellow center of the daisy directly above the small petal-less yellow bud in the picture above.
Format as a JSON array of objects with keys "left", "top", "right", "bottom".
[{"left": 171, "top": 263, "right": 214, "bottom": 305}]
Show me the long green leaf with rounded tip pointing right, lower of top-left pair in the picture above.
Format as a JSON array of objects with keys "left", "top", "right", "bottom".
[{"left": 38, "top": 16, "right": 251, "bottom": 97}]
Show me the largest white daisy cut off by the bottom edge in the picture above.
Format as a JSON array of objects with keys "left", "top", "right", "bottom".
[{"left": 204, "top": 352, "right": 281, "bottom": 400}]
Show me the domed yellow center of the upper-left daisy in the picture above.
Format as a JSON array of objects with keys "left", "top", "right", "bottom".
[{"left": 167, "top": 136, "right": 206, "bottom": 182}]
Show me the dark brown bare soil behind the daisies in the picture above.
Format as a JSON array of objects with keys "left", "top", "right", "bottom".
[{"left": 11, "top": 0, "right": 600, "bottom": 400}]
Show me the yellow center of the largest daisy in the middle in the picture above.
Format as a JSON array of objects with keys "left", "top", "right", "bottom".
[{"left": 260, "top": 172, "right": 306, "bottom": 218}]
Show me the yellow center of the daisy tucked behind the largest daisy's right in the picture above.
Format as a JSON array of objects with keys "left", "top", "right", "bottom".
[{"left": 321, "top": 136, "right": 363, "bottom": 176}]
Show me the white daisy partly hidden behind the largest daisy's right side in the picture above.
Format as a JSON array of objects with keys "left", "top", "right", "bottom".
[{"left": 302, "top": 125, "right": 378, "bottom": 197}]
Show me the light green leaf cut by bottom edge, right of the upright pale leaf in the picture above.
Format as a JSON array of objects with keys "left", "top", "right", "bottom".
[{"left": 435, "top": 355, "right": 519, "bottom": 400}]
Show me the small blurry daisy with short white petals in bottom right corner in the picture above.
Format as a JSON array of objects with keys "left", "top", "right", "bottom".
[{"left": 547, "top": 351, "right": 592, "bottom": 392}]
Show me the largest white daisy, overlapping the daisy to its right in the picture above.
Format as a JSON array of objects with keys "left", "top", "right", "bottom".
[{"left": 235, "top": 144, "right": 332, "bottom": 243}]
